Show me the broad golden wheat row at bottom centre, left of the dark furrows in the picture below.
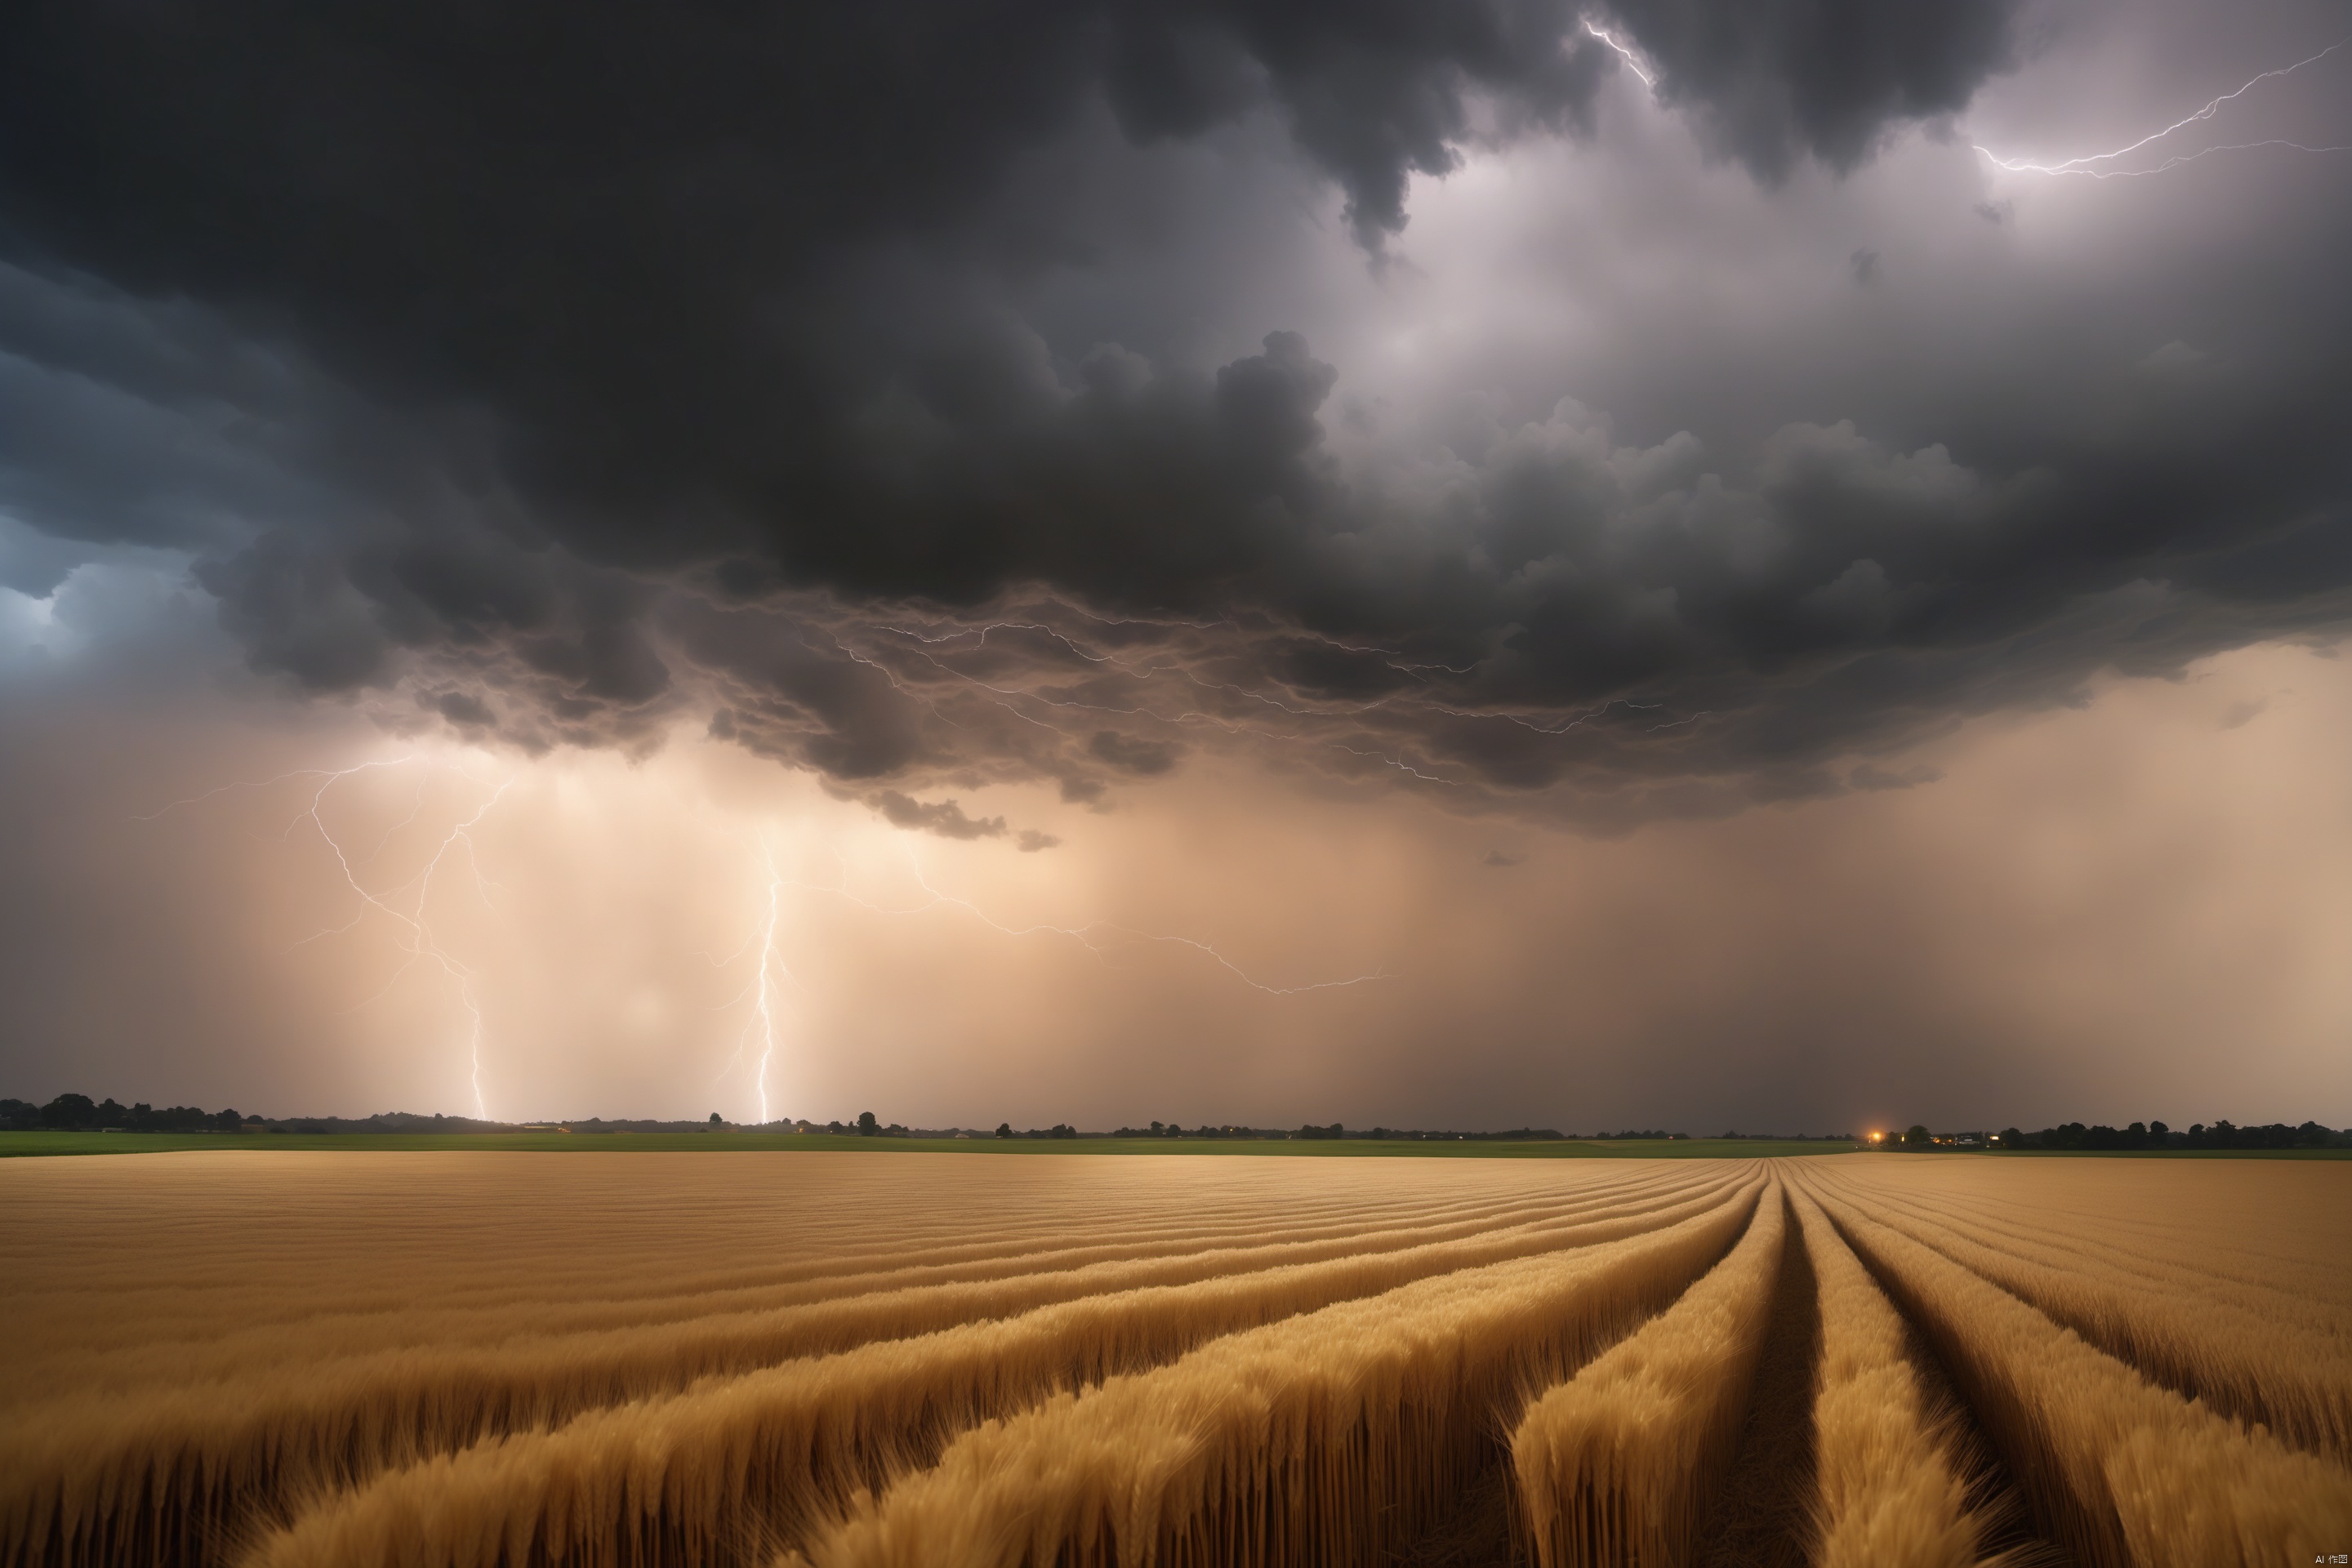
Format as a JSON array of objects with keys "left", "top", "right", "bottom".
[{"left": 791, "top": 1180, "right": 1762, "bottom": 1568}]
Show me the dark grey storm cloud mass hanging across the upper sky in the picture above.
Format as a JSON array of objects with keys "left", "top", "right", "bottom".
[{"left": 0, "top": 0, "right": 2352, "bottom": 822}]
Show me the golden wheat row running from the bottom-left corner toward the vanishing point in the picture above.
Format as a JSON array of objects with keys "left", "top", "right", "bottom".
[{"left": 0, "top": 1156, "right": 1695, "bottom": 1558}]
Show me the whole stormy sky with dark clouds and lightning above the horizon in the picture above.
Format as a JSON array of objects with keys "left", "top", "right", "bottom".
[{"left": 0, "top": 0, "right": 2352, "bottom": 1133}]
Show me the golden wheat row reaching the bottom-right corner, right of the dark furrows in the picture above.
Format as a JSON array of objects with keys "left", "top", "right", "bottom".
[{"left": 1815, "top": 1175, "right": 2352, "bottom": 1568}]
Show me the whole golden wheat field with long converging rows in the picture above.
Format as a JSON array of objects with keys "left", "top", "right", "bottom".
[{"left": 0, "top": 1152, "right": 2352, "bottom": 1568}]
